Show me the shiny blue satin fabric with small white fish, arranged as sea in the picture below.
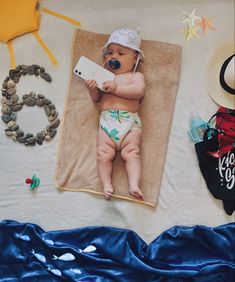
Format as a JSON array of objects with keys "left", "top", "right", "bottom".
[{"left": 0, "top": 220, "right": 235, "bottom": 282}]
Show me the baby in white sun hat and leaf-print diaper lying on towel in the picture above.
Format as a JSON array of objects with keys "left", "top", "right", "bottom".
[{"left": 85, "top": 28, "right": 145, "bottom": 200}]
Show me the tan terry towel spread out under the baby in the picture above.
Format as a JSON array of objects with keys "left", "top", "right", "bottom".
[{"left": 55, "top": 30, "right": 181, "bottom": 207}]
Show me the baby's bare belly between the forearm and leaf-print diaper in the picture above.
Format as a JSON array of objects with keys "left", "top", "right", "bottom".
[{"left": 99, "top": 94, "right": 139, "bottom": 113}]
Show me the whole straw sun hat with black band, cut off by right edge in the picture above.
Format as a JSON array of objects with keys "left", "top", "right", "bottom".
[{"left": 206, "top": 42, "right": 235, "bottom": 110}]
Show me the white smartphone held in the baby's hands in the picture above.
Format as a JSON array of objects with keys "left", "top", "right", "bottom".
[{"left": 73, "top": 56, "right": 115, "bottom": 90}]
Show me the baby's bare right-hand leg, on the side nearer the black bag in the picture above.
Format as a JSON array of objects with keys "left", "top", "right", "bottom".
[{"left": 121, "top": 129, "right": 143, "bottom": 200}]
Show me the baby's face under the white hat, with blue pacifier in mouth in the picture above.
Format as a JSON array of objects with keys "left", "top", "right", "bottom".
[{"left": 106, "top": 43, "right": 137, "bottom": 74}]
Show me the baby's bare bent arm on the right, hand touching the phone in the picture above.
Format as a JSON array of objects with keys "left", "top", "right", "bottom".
[{"left": 103, "top": 72, "right": 145, "bottom": 99}]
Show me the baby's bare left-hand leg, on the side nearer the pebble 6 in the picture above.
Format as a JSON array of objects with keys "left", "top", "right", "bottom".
[{"left": 97, "top": 129, "right": 116, "bottom": 200}]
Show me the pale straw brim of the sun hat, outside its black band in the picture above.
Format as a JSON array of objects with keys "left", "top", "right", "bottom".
[{"left": 205, "top": 41, "right": 235, "bottom": 110}]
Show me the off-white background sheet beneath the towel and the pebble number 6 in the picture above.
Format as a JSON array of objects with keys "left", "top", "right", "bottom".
[{"left": 0, "top": 0, "right": 234, "bottom": 242}]
